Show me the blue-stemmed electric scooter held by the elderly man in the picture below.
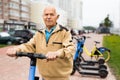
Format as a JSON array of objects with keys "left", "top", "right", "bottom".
[{"left": 16, "top": 52, "right": 46, "bottom": 80}]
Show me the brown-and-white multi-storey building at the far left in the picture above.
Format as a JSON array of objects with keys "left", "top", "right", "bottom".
[{"left": 0, "top": 0, "right": 35, "bottom": 30}]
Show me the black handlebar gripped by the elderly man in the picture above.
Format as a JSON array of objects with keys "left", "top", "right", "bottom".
[{"left": 16, "top": 52, "right": 46, "bottom": 59}]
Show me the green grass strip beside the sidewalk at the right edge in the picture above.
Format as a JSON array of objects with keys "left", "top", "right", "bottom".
[{"left": 103, "top": 35, "right": 120, "bottom": 80}]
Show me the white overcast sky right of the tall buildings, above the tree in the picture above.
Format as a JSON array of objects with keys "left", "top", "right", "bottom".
[{"left": 83, "top": 0, "right": 119, "bottom": 27}]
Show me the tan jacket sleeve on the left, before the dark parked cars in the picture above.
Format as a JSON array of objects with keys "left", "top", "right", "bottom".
[{"left": 17, "top": 31, "right": 37, "bottom": 52}]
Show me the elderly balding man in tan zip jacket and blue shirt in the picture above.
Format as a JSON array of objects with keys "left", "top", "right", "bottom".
[{"left": 7, "top": 6, "right": 75, "bottom": 80}]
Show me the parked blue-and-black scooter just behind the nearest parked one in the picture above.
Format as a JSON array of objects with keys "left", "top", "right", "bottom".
[{"left": 73, "top": 36, "right": 105, "bottom": 66}]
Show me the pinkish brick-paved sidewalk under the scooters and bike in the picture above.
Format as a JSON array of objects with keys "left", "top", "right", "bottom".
[{"left": 0, "top": 33, "right": 116, "bottom": 80}]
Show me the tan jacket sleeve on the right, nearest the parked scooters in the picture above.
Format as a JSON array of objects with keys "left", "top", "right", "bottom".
[{"left": 58, "top": 31, "right": 75, "bottom": 59}]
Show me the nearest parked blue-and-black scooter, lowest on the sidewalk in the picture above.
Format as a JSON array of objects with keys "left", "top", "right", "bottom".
[{"left": 71, "top": 37, "right": 108, "bottom": 78}]
